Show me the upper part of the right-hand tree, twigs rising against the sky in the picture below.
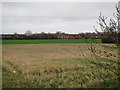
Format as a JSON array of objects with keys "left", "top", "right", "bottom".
[{"left": 94, "top": 5, "right": 120, "bottom": 43}]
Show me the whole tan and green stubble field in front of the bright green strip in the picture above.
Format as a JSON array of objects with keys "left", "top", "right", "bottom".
[{"left": 2, "top": 41, "right": 119, "bottom": 88}]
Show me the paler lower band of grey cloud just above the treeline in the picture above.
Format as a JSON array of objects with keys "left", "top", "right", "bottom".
[{"left": 3, "top": 17, "right": 96, "bottom": 33}]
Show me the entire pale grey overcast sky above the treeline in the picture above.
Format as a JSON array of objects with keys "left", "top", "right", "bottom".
[{"left": 2, "top": 2, "right": 116, "bottom": 33}]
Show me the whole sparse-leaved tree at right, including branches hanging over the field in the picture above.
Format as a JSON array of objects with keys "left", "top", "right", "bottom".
[{"left": 79, "top": 2, "right": 120, "bottom": 86}]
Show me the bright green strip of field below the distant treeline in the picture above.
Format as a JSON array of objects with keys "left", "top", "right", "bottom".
[{"left": 2, "top": 39, "right": 102, "bottom": 44}]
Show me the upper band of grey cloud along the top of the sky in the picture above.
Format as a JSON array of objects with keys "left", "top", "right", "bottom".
[{"left": 3, "top": 2, "right": 115, "bottom": 17}]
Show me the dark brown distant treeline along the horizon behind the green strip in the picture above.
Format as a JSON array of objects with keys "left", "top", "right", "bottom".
[{"left": 0, "top": 33, "right": 114, "bottom": 43}]
